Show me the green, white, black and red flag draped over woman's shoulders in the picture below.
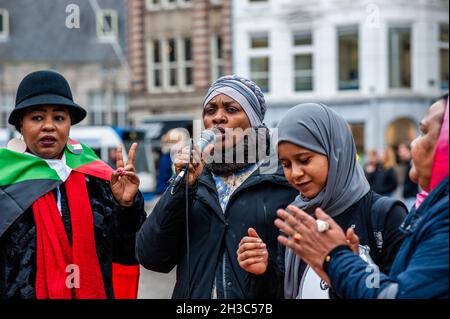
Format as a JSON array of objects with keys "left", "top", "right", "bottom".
[{"left": 0, "top": 140, "right": 113, "bottom": 237}]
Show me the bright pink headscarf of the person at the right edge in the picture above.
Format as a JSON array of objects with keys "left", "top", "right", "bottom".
[{"left": 415, "top": 98, "right": 449, "bottom": 209}]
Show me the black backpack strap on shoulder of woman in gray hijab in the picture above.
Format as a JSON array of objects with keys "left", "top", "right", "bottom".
[{"left": 369, "top": 196, "right": 408, "bottom": 268}]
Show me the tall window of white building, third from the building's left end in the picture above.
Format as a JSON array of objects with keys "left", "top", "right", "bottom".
[{"left": 338, "top": 27, "right": 359, "bottom": 90}]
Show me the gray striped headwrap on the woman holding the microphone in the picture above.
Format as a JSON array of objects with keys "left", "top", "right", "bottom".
[{"left": 203, "top": 75, "right": 267, "bottom": 127}]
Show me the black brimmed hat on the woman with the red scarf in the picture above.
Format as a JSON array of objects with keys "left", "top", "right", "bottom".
[{"left": 8, "top": 70, "right": 86, "bottom": 132}]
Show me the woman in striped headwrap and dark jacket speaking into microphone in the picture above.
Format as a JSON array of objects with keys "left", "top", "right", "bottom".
[{"left": 136, "top": 76, "right": 296, "bottom": 299}]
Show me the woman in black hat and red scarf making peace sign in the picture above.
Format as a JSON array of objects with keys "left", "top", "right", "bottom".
[{"left": 0, "top": 71, "right": 146, "bottom": 299}]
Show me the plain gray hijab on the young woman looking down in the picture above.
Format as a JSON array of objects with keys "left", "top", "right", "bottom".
[{"left": 278, "top": 103, "right": 370, "bottom": 299}]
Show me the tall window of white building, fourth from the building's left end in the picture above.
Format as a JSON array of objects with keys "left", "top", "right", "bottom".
[{"left": 389, "top": 27, "right": 411, "bottom": 88}]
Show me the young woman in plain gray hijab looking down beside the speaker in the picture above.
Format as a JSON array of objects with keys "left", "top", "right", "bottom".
[{"left": 237, "top": 103, "right": 407, "bottom": 299}]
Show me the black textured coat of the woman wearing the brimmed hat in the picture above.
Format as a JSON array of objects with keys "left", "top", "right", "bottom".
[{"left": 0, "top": 176, "right": 146, "bottom": 299}]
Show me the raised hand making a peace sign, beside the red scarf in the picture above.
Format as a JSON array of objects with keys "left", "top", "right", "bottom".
[{"left": 111, "top": 143, "right": 139, "bottom": 206}]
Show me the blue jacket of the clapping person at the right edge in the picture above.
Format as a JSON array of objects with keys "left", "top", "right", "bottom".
[{"left": 328, "top": 177, "right": 449, "bottom": 299}]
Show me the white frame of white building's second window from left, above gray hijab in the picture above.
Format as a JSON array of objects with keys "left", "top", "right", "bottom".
[{"left": 291, "top": 29, "right": 316, "bottom": 94}]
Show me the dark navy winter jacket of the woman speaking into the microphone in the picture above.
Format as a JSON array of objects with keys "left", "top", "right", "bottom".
[{"left": 136, "top": 162, "right": 298, "bottom": 299}]
